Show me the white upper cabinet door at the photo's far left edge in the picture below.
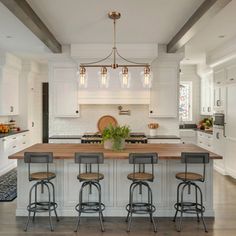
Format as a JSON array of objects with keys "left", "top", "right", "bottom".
[{"left": 0, "top": 69, "right": 19, "bottom": 116}]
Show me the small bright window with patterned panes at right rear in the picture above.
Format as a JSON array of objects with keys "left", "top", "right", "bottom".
[{"left": 179, "top": 81, "right": 192, "bottom": 121}]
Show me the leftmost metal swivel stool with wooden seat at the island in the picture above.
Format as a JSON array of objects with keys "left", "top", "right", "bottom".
[{"left": 24, "top": 152, "right": 59, "bottom": 231}]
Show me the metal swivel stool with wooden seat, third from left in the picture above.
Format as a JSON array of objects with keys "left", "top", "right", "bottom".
[{"left": 126, "top": 153, "right": 158, "bottom": 232}]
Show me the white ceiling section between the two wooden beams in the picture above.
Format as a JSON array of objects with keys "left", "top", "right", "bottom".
[{"left": 27, "top": 0, "right": 203, "bottom": 44}]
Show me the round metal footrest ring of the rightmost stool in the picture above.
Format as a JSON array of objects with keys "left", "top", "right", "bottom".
[{"left": 174, "top": 202, "right": 205, "bottom": 214}]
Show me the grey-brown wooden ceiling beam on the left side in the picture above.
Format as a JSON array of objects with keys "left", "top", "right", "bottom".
[{"left": 0, "top": 0, "right": 62, "bottom": 53}]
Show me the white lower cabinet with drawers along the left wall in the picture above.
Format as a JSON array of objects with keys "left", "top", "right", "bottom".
[{"left": 0, "top": 132, "right": 30, "bottom": 175}]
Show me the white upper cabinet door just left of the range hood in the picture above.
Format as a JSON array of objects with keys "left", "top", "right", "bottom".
[{"left": 53, "top": 68, "right": 79, "bottom": 117}]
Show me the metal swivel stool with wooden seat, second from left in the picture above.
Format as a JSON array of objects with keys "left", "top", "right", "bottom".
[{"left": 75, "top": 153, "right": 105, "bottom": 232}]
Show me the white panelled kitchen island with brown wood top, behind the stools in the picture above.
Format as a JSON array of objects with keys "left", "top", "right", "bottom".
[{"left": 9, "top": 144, "right": 222, "bottom": 217}]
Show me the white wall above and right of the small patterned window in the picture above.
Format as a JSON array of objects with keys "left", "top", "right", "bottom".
[{"left": 180, "top": 65, "right": 201, "bottom": 124}]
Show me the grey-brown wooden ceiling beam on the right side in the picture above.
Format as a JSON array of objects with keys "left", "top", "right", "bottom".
[{"left": 167, "top": 0, "right": 232, "bottom": 53}]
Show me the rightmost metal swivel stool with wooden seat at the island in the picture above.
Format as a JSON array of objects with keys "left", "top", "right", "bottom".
[{"left": 173, "top": 152, "right": 209, "bottom": 232}]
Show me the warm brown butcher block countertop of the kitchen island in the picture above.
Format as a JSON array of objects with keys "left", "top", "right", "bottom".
[{"left": 9, "top": 143, "right": 222, "bottom": 160}]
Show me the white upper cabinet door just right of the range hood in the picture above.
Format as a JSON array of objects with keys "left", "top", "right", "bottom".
[{"left": 149, "top": 67, "right": 178, "bottom": 117}]
